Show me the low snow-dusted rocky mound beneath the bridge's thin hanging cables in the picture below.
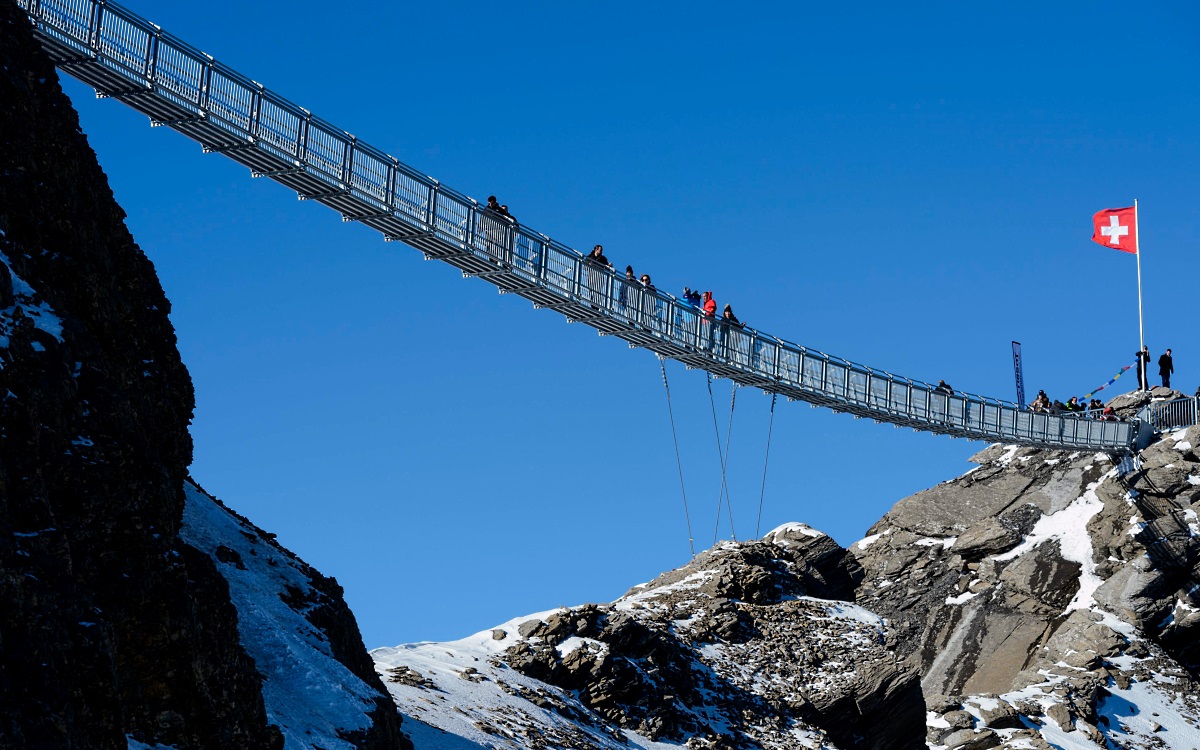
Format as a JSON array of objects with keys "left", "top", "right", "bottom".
[{"left": 374, "top": 524, "right": 924, "bottom": 750}]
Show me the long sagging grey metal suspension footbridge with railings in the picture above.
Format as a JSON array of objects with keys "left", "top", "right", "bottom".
[{"left": 17, "top": 0, "right": 1136, "bottom": 451}]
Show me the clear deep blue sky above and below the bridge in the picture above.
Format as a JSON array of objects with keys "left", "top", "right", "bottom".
[{"left": 65, "top": 0, "right": 1200, "bottom": 647}]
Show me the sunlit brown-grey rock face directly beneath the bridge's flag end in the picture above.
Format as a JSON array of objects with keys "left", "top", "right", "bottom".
[{"left": 851, "top": 429, "right": 1200, "bottom": 748}]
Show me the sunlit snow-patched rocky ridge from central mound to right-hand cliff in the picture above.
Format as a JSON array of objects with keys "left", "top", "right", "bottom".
[{"left": 373, "top": 410, "right": 1200, "bottom": 750}]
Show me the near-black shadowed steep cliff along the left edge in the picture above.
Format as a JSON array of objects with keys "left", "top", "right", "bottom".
[{"left": 0, "top": 0, "right": 403, "bottom": 750}]
